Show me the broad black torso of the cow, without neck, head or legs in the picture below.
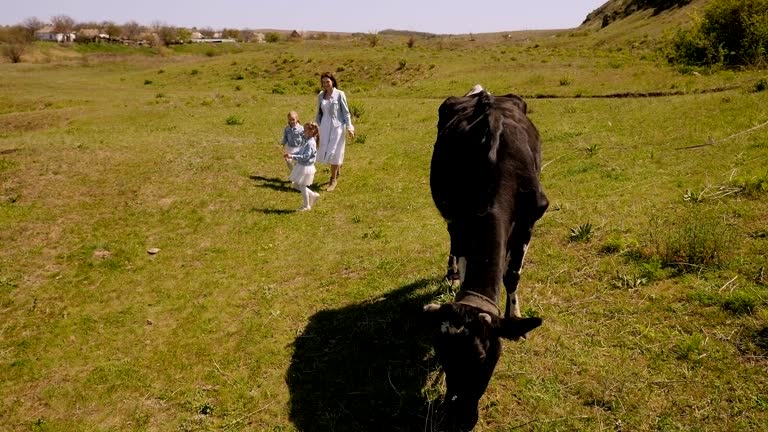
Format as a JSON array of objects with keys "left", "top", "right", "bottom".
[{"left": 430, "top": 91, "right": 541, "bottom": 220}]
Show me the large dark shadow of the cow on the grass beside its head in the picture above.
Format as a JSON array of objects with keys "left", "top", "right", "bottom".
[{"left": 286, "top": 279, "right": 439, "bottom": 432}]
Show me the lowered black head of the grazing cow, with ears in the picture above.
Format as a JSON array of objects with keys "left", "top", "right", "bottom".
[{"left": 424, "top": 303, "right": 541, "bottom": 431}]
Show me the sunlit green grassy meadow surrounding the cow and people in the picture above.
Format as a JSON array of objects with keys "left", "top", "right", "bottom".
[{"left": 0, "top": 32, "right": 768, "bottom": 432}]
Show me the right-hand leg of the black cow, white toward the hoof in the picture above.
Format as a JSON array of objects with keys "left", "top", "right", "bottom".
[{"left": 503, "top": 192, "right": 549, "bottom": 318}]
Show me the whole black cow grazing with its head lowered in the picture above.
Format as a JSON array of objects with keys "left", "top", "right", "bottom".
[{"left": 424, "top": 86, "right": 549, "bottom": 431}]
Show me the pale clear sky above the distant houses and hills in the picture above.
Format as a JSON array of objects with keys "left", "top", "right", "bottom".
[{"left": 0, "top": 0, "right": 607, "bottom": 34}]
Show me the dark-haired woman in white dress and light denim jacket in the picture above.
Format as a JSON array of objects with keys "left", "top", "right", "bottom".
[{"left": 315, "top": 72, "right": 355, "bottom": 191}]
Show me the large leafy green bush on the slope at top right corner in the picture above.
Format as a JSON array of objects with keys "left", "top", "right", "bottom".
[{"left": 666, "top": 0, "right": 768, "bottom": 66}]
